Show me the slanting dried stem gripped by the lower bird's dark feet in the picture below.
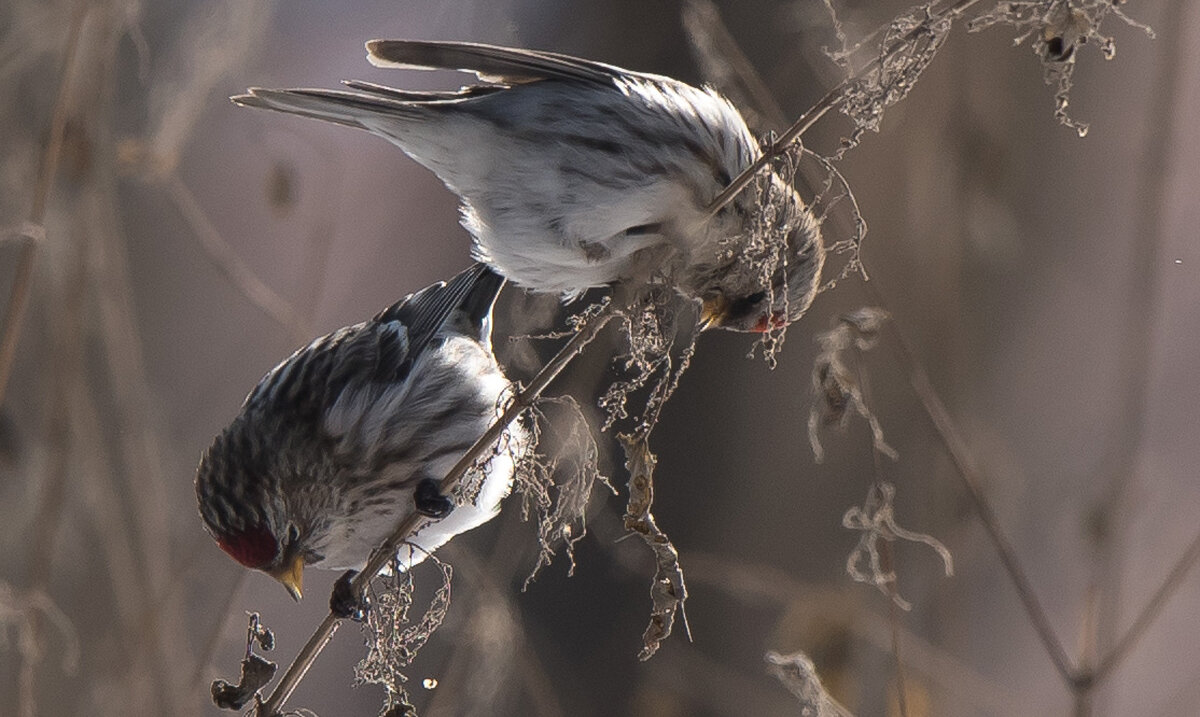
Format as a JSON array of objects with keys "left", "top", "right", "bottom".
[{"left": 257, "top": 303, "right": 622, "bottom": 717}]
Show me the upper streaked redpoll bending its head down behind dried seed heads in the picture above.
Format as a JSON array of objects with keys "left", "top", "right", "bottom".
[{"left": 233, "top": 40, "right": 824, "bottom": 331}]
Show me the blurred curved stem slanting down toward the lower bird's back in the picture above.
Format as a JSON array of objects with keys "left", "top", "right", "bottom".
[{"left": 162, "top": 171, "right": 312, "bottom": 342}]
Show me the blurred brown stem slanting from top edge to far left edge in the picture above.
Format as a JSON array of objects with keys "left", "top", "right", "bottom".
[{"left": 0, "top": 0, "right": 88, "bottom": 404}]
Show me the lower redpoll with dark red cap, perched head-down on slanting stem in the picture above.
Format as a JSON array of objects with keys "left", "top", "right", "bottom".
[{"left": 196, "top": 264, "right": 529, "bottom": 606}]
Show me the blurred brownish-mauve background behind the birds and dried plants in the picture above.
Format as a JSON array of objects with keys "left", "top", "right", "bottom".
[{"left": 0, "top": 0, "right": 1200, "bottom": 717}]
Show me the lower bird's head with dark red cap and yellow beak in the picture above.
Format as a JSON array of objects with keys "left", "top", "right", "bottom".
[{"left": 196, "top": 423, "right": 307, "bottom": 599}]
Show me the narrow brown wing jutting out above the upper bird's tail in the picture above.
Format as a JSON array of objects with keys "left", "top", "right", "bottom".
[{"left": 367, "top": 40, "right": 638, "bottom": 85}]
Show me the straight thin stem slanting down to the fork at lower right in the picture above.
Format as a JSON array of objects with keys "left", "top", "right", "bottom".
[{"left": 864, "top": 282, "right": 1078, "bottom": 685}]
